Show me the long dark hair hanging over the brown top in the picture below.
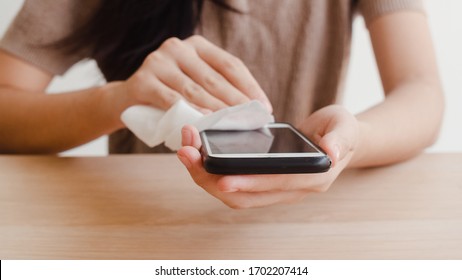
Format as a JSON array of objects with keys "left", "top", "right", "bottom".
[{"left": 58, "top": 0, "right": 208, "bottom": 81}]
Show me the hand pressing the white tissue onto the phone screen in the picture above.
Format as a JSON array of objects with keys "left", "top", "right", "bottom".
[{"left": 119, "top": 35, "right": 272, "bottom": 115}]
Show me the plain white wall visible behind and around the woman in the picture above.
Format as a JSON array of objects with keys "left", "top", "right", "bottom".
[{"left": 0, "top": 0, "right": 462, "bottom": 156}]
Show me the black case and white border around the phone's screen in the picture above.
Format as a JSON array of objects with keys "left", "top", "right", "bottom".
[{"left": 200, "top": 123, "right": 331, "bottom": 175}]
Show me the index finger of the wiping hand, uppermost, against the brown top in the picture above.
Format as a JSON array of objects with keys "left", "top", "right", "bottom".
[{"left": 186, "top": 36, "right": 273, "bottom": 112}]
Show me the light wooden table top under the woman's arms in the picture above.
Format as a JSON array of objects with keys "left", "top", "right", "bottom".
[{"left": 0, "top": 154, "right": 462, "bottom": 259}]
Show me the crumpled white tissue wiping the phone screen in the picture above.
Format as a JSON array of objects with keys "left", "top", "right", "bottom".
[{"left": 121, "top": 100, "right": 274, "bottom": 151}]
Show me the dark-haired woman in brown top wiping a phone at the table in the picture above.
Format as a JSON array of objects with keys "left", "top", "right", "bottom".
[{"left": 0, "top": 0, "right": 443, "bottom": 208}]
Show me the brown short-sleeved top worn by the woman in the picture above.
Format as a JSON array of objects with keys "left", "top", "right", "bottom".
[{"left": 0, "top": 0, "right": 423, "bottom": 153}]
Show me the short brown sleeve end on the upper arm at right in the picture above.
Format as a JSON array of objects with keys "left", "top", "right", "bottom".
[{"left": 358, "top": 0, "right": 424, "bottom": 26}]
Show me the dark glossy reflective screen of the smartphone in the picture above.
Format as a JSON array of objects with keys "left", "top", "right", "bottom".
[{"left": 206, "top": 127, "right": 319, "bottom": 154}]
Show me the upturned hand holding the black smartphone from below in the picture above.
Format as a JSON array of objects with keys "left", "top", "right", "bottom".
[{"left": 178, "top": 105, "right": 359, "bottom": 208}]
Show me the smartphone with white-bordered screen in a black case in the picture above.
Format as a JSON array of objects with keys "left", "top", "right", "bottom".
[{"left": 200, "top": 123, "right": 331, "bottom": 174}]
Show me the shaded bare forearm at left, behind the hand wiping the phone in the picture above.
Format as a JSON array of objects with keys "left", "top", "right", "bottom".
[{"left": 0, "top": 84, "right": 127, "bottom": 153}]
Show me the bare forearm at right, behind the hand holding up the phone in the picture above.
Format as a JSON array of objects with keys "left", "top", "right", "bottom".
[{"left": 349, "top": 82, "right": 444, "bottom": 167}]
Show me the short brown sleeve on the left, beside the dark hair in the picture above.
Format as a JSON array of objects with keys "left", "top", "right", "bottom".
[{"left": 0, "top": 0, "right": 96, "bottom": 75}]
